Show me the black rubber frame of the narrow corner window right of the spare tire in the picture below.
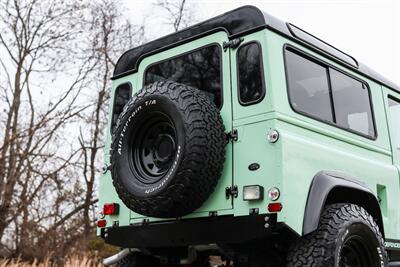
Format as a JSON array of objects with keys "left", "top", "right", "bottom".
[{"left": 236, "top": 40, "right": 266, "bottom": 106}]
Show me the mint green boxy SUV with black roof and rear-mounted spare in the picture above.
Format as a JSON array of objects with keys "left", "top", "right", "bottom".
[{"left": 98, "top": 6, "right": 400, "bottom": 267}]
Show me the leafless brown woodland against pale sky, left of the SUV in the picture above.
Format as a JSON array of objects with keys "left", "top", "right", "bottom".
[{"left": 0, "top": 0, "right": 195, "bottom": 264}]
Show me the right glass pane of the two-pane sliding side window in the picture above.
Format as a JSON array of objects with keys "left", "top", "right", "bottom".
[{"left": 329, "top": 69, "right": 375, "bottom": 136}]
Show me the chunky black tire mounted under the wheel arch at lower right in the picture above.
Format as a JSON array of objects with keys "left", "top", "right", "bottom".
[{"left": 287, "top": 204, "right": 388, "bottom": 267}]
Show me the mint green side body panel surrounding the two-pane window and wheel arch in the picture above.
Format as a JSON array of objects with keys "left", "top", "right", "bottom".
[{"left": 267, "top": 28, "right": 400, "bottom": 238}]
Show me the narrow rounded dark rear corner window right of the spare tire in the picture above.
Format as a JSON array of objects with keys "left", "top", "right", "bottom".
[{"left": 237, "top": 42, "right": 265, "bottom": 105}]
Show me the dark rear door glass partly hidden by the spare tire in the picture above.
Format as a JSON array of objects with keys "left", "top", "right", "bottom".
[{"left": 144, "top": 44, "right": 222, "bottom": 107}]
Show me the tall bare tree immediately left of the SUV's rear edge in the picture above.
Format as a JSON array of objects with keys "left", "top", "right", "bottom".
[{"left": 79, "top": 0, "right": 144, "bottom": 239}]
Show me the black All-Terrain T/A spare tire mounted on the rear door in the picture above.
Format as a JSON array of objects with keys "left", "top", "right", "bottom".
[{"left": 111, "top": 81, "right": 226, "bottom": 218}]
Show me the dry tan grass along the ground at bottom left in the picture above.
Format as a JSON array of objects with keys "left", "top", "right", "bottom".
[{"left": 0, "top": 256, "right": 103, "bottom": 267}]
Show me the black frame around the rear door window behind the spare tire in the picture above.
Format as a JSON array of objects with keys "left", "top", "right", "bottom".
[{"left": 142, "top": 42, "right": 224, "bottom": 110}]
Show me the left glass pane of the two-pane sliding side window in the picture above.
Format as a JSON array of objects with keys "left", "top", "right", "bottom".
[{"left": 286, "top": 50, "right": 333, "bottom": 122}]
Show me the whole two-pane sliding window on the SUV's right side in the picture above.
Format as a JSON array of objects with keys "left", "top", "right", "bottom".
[{"left": 285, "top": 48, "right": 376, "bottom": 138}]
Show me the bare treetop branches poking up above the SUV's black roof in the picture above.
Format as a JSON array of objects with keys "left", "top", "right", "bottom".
[{"left": 154, "top": 0, "right": 195, "bottom": 32}]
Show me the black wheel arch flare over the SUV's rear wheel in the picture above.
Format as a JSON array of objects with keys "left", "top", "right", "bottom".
[{"left": 303, "top": 171, "right": 384, "bottom": 236}]
